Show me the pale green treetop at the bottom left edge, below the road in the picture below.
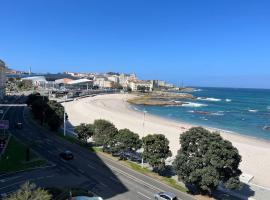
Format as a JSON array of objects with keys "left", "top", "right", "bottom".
[{"left": 5, "top": 182, "right": 52, "bottom": 200}]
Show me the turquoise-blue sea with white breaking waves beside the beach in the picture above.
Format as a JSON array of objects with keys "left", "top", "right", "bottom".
[{"left": 135, "top": 88, "right": 270, "bottom": 140}]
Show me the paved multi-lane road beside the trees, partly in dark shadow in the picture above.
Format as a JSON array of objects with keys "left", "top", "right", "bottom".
[{"left": 0, "top": 101, "right": 194, "bottom": 200}]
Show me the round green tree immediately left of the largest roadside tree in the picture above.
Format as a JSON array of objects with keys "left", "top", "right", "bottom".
[{"left": 142, "top": 134, "right": 172, "bottom": 173}]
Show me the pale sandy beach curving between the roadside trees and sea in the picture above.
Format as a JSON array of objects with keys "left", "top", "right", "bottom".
[{"left": 65, "top": 94, "right": 270, "bottom": 188}]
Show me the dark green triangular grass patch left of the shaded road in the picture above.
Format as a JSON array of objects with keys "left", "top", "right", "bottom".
[{"left": 0, "top": 136, "right": 46, "bottom": 172}]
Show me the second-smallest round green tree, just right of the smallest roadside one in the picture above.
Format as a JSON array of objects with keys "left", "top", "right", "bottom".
[{"left": 93, "top": 119, "right": 118, "bottom": 151}]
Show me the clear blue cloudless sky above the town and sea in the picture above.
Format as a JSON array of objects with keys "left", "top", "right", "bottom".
[{"left": 0, "top": 0, "right": 270, "bottom": 88}]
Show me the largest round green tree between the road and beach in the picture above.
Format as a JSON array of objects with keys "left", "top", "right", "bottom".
[{"left": 173, "top": 127, "right": 242, "bottom": 195}]
